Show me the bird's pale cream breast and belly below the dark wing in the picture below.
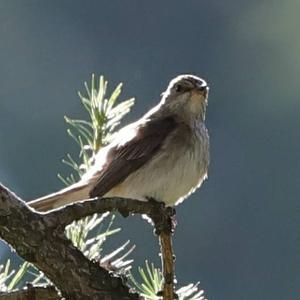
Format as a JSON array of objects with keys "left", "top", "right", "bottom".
[{"left": 107, "top": 125, "right": 209, "bottom": 206}]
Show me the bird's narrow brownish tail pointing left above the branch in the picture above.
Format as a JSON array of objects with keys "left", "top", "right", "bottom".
[{"left": 27, "top": 181, "right": 90, "bottom": 211}]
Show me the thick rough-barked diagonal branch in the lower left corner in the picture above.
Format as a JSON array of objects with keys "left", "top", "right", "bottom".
[{"left": 0, "top": 184, "right": 139, "bottom": 300}]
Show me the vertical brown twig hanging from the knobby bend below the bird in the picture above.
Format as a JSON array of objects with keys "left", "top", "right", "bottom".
[{"left": 148, "top": 198, "right": 178, "bottom": 300}]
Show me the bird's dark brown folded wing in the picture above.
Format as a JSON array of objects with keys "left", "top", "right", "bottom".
[{"left": 90, "top": 116, "right": 177, "bottom": 198}]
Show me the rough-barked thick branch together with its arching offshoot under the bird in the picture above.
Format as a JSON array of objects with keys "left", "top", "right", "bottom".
[{"left": 0, "top": 184, "right": 175, "bottom": 300}]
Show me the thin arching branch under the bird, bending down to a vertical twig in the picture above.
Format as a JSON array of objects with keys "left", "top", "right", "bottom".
[{"left": 44, "top": 197, "right": 176, "bottom": 300}]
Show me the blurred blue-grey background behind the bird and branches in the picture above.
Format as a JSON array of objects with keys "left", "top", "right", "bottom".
[{"left": 0, "top": 0, "right": 300, "bottom": 300}]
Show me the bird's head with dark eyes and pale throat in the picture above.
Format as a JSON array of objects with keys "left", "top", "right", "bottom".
[{"left": 161, "top": 75, "right": 209, "bottom": 120}]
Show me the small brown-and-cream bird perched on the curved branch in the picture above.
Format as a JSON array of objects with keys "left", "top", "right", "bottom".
[{"left": 28, "top": 74, "right": 210, "bottom": 211}]
